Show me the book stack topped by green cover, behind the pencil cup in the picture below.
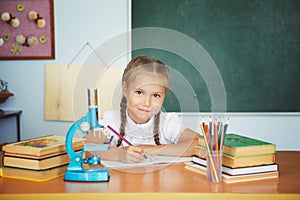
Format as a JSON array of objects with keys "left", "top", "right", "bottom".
[{"left": 185, "top": 133, "right": 279, "bottom": 183}]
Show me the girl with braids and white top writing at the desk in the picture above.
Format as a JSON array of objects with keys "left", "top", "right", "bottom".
[{"left": 87, "top": 56, "right": 196, "bottom": 163}]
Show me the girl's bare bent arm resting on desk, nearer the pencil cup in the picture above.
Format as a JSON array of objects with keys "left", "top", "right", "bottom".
[{"left": 139, "top": 129, "right": 198, "bottom": 156}]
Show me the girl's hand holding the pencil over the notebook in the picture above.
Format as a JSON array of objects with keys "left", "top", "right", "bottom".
[{"left": 119, "top": 146, "right": 145, "bottom": 163}]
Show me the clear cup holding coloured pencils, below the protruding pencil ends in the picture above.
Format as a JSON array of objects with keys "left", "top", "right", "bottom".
[{"left": 206, "top": 151, "right": 222, "bottom": 183}]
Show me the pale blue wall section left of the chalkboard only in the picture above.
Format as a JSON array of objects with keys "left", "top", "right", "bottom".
[{"left": 0, "top": 0, "right": 129, "bottom": 143}]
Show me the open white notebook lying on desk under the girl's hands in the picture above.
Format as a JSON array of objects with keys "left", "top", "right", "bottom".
[{"left": 101, "top": 156, "right": 192, "bottom": 168}]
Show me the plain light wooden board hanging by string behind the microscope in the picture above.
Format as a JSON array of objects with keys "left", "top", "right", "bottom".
[{"left": 44, "top": 64, "right": 124, "bottom": 121}]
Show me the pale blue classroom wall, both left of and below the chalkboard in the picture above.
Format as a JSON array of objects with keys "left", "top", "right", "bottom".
[{"left": 0, "top": 0, "right": 300, "bottom": 150}]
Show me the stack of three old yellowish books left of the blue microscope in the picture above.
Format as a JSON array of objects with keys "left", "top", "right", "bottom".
[{"left": 0, "top": 135, "right": 83, "bottom": 181}]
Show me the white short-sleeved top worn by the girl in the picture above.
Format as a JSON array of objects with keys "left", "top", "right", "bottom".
[{"left": 102, "top": 110, "right": 186, "bottom": 146}]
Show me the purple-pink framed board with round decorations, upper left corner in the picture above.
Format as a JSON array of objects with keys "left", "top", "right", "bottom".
[{"left": 0, "top": 0, "right": 55, "bottom": 60}]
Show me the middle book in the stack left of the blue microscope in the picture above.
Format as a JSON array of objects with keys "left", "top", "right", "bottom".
[{"left": 3, "top": 153, "right": 70, "bottom": 170}]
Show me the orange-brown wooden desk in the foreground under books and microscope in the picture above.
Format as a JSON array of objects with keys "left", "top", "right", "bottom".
[{"left": 0, "top": 151, "right": 300, "bottom": 200}]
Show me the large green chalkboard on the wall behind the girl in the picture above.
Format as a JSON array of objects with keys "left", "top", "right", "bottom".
[{"left": 132, "top": 0, "right": 300, "bottom": 112}]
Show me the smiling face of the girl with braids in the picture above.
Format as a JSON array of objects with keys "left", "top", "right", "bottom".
[{"left": 123, "top": 73, "right": 166, "bottom": 124}]
